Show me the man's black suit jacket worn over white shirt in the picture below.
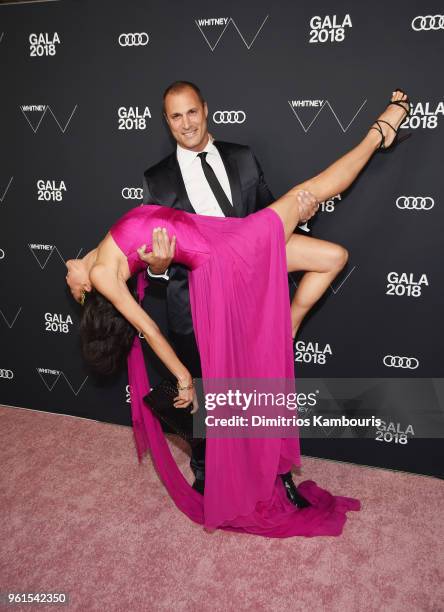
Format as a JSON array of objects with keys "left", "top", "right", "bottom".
[{"left": 143, "top": 140, "right": 274, "bottom": 334}]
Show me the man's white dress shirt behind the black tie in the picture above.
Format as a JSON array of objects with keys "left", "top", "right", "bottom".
[{"left": 147, "top": 137, "right": 233, "bottom": 280}]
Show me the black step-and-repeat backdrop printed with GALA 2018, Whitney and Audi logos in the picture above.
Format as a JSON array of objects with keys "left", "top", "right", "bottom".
[{"left": 0, "top": 0, "right": 444, "bottom": 476}]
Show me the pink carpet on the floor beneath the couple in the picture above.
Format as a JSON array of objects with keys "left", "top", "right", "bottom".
[{"left": 0, "top": 407, "right": 444, "bottom": 612}]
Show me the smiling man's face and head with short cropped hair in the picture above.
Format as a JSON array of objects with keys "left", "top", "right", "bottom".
[{"left": 165, "top": 87, "right": 208, "bottom": 151}]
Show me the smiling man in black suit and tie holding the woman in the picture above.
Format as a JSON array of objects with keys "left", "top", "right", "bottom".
[{"left": 143, "top": 81, "right": 317, "bottom": 505}]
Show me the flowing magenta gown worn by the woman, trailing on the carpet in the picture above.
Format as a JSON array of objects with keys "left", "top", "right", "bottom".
[{"left": 110, "top": 205, "right": 360, "bottom": 538}]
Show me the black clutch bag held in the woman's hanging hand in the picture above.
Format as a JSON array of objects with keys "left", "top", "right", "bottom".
[{"left": 143, "top": 380, "right": 202, "bottom": 446}]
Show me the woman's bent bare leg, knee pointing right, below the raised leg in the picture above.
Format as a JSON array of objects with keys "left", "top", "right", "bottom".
[{"left": 286, "top": 234, "right": 348, "bottom": 338}]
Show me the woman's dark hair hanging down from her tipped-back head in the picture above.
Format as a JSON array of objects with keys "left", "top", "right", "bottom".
[{"left": 80, "top": 289, "right": 137, "bottom": 376}]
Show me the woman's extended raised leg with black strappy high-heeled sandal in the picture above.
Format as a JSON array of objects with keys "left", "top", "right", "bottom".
[{"left": 270, "top": 90, "right": 407, "bottom": 241}]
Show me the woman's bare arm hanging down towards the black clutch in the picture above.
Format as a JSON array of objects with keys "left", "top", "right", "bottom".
[{"left": 89, "top": 263, "right": 193, "bottom": 407}]
